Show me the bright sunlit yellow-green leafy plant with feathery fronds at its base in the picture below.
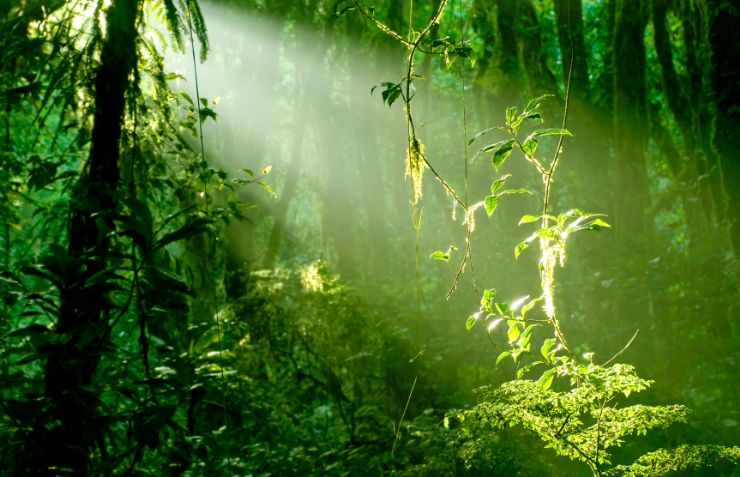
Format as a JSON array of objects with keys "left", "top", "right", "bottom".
[{"left": 460, "top": 96, "right": 740, "bottom": 476}]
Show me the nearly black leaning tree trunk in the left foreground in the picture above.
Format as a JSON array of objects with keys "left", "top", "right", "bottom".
[{"left": 42, "top": 0, "right": 139, "bottom": 475}]
